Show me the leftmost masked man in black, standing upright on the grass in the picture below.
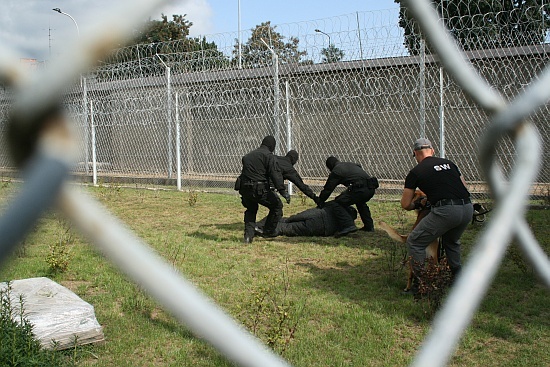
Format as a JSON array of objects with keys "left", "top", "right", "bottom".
[{"left": 235, "top": 135, "right": 290, "bottom": 243}]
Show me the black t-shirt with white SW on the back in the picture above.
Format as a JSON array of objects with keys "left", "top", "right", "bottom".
[{"left": 405, "top": 157, "right": 470, "bottom": 204}]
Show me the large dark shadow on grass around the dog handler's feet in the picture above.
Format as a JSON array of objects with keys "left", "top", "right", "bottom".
[{"left": 294, "top": 218, "right": 550, "bottom": 330}]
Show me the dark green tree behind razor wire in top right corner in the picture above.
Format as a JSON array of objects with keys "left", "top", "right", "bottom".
[{"left": 394, "top": 0, "right": 550, "bottom": 55}]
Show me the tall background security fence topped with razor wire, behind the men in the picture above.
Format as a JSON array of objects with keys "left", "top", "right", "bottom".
[{"left": 0, "top": 5, "right": 550, "bottom": 197}]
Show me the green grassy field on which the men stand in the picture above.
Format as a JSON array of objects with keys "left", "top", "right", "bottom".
[{"left": 0, "top": 184, "right": 550, "bottom": 367}]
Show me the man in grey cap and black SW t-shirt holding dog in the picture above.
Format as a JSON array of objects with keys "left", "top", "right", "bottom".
[{"left": 401, "top": 139, "right": 474, "bottom": 294}]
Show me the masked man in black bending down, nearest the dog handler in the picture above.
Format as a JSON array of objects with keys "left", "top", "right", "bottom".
[{"left": 318, "top": 156, "right": 378, "bottom": 236}]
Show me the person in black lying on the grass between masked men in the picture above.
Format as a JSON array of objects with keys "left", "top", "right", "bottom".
[{"left": 256, "top": 201, "right": 357, "bottom": 237}]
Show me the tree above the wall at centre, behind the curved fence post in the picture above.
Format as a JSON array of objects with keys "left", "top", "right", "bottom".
[{"left": 233, "top": 21, "right": 307, "bottom": 67}]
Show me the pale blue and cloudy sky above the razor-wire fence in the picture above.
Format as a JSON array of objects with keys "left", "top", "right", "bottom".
[{"left": 0, "top": 0, "right": 399, "bottom": 61}]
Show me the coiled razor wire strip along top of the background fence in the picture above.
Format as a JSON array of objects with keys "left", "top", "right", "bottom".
[{"left": 90, "top": 2, "right": 549, "bottom": 78}]
